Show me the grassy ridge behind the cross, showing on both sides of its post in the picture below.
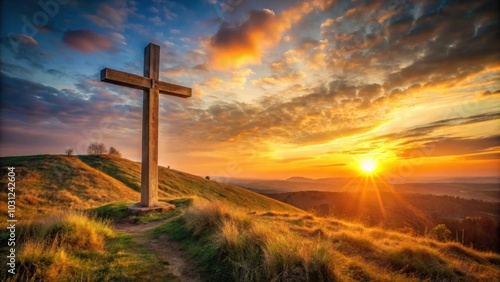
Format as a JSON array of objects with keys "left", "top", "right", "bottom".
[{"left": 0, "top": 155, "right": 297, "bottom": 217}]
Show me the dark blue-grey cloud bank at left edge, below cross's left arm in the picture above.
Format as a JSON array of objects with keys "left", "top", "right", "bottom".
[{"left": 1, "top": 71, "right": 140, "bottom": 133}]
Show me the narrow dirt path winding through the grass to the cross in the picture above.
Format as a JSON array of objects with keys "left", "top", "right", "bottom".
[{"left": 114, "top": 217, "right": 203, "bottom": 282}]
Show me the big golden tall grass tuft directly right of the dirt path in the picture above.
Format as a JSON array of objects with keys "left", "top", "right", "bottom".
[{"left": 179, "top": 201, "right": 335, "bottom": 281}]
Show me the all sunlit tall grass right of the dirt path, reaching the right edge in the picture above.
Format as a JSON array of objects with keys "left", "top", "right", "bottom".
[{"left": 159, "top": 199, "right": 500, "bottom": 281}]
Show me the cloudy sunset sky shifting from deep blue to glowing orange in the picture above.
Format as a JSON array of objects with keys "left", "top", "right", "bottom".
[{"left": 0, "top": 0, "right": 500, "bottom": 182}]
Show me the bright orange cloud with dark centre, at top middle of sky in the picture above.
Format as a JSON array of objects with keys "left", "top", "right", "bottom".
[{"left": 208, "top": 0, "right": 333, "bottom": 70}]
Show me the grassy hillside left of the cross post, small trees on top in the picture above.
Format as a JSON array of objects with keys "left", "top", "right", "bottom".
[{"left": 0, "top": 155, "right": 140, "bottom": 219}]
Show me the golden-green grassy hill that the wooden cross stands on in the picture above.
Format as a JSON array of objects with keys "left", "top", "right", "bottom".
[{"left": 0, "top": 156, "right": 500, "bottom": 281}]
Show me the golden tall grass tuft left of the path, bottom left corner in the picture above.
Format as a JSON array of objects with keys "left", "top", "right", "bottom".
[{"left": 4, "top": 211, "right": 115, "bottom": 281}]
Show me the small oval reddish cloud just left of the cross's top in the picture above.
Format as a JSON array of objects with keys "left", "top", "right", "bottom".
[{"left": 62, "top": 29, "right": 114, "bottom": 53}]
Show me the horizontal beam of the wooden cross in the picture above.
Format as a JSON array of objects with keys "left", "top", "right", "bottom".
[{"left": 101, "top": 68, "right": 192, "bottom": 98}]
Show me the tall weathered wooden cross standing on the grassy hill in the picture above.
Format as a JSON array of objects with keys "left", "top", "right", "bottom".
[{"left": 101, "top": 43, "right": 191, "bottom": 207}]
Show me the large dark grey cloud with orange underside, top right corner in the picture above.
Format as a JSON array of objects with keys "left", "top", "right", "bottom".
[{"left": 320, "top": 0, "right": 499, "bottom": 96}]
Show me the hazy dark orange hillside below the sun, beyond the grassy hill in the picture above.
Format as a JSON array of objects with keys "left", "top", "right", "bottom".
[{"left": 267, "top": 191, "right": 500, "bottom": 252}]
